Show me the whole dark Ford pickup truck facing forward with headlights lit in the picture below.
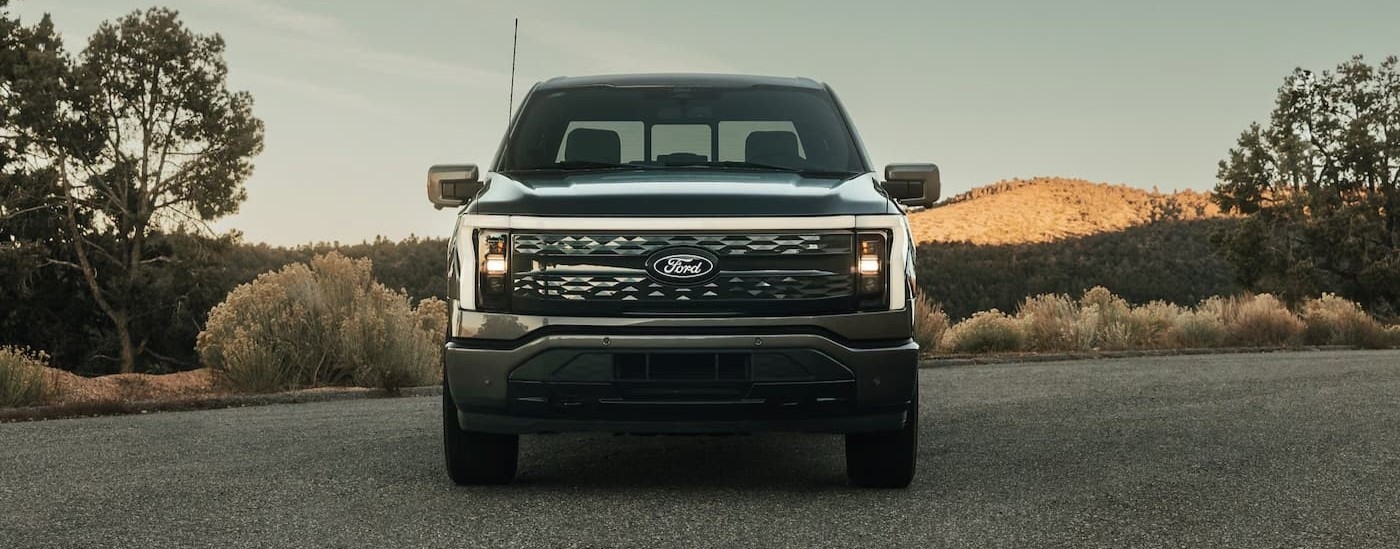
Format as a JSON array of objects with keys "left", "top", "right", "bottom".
[{"left": 427, "top": 74, "right": 939, "bottom": 487}]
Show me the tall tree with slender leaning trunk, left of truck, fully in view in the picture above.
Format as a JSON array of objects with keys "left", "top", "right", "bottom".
[{"left": 50, "top": 8, "right": 263, "bottom": 373}]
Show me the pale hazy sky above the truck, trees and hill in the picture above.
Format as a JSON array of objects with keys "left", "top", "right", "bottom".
[{"left": 11, "top": 0, "right": 1400, "bottom": 245}]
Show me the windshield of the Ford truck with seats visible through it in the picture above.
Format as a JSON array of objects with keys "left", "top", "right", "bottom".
[{"left": 497, "top": 87, "right": 867, "bottom": 174}]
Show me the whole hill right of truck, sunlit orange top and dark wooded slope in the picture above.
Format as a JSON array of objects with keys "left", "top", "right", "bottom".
[{"left": 910, "top": 178, "right": 1240, "bottom": 319}]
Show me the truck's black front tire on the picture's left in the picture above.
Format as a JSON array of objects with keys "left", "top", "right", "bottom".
[{"left": 442, "top": 377, "right": 521, "bottom": 486}]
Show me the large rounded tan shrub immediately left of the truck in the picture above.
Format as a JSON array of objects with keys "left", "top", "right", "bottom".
[{"left": 196, "top": 252, "right": 447, "bottom": 392}]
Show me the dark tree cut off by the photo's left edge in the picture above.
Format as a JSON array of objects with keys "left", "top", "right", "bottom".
[{"left": 0, "top": 0, "right": 94, "bottom": 369}]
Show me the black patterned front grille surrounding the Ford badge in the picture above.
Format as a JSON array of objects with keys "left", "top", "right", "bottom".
[{"left": 511, "top": 231, "right": 855, "bottom": 315}]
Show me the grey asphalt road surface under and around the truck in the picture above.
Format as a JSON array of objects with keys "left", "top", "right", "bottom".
[{"left": 0, "top": 352, "right": 1400, "bottom": 548}]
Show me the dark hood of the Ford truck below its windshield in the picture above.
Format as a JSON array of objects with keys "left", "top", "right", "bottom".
[{"left": 466, "top": 169, "right": 896, "bottom": 217}]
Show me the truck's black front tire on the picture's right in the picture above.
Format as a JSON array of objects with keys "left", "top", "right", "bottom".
[{"left": 846, "top": 392, "right": 918, "bottom": 487}]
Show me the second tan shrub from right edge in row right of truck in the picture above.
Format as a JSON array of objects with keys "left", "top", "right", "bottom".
[{"left": 1201, "top": 294, "right": 1305, "bottom": 347}]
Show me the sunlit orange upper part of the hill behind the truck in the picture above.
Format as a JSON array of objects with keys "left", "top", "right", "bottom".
[{"left": 909, "top": 178, "right": 1222, "bottom": 245}]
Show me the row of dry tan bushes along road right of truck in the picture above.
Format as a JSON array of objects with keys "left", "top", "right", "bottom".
[{"left": 916, "top": 287, "right": 1400, "bottom": 353}]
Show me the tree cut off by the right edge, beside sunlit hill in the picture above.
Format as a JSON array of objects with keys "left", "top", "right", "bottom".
[{"left": 1215, "top": 56, "right": 1400, "bottom": 312}]
